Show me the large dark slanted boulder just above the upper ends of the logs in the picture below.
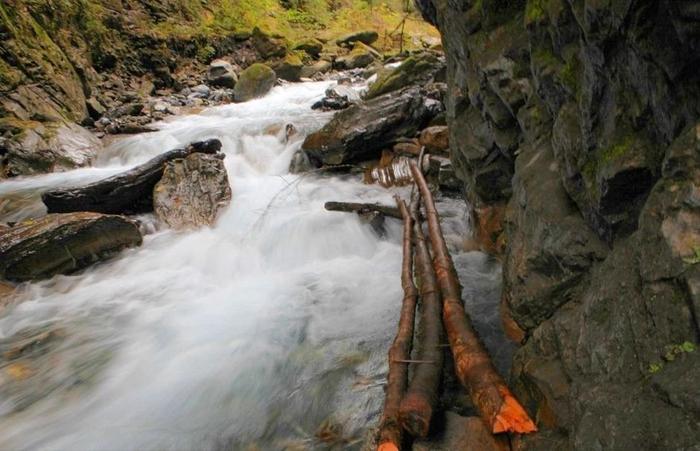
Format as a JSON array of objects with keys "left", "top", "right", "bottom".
[{"left": 302, "top": 88, "right": 442, "bottom": 167}]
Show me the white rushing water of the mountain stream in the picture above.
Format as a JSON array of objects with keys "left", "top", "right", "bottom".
[{"left": 0, "top": 82, "right": 507, "bottom": 450}]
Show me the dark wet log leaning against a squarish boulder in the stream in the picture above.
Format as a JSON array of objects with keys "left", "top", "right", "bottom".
[{"left": 41, "top": 139, "right": 221, "bottom": 214}]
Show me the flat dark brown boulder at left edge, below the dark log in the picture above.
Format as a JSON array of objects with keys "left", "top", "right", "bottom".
[{"left": 0, "top": 212, "right": 141, "bottom": 281}]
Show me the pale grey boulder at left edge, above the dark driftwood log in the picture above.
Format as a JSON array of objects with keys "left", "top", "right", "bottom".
[{"left": 0, "top": 119, "right": 102, "bottom": 177}]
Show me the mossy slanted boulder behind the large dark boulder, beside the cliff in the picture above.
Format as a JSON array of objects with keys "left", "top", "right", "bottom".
[{"left": 366, "top": 52, "right": 445, "bottom": 99}]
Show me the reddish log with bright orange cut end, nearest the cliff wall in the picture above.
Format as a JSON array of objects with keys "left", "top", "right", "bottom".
[{"left": 411, "top": 162, "right": 537, "bottom": 434}]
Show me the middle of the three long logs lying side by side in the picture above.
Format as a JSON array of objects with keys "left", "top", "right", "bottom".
[{"left": 399, "top": 186, "right": 443, "bottom": 438}]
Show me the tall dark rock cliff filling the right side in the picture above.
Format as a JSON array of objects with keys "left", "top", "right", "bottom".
[{"left": 416, "top": 0, "right": 700, "bottom": 450}]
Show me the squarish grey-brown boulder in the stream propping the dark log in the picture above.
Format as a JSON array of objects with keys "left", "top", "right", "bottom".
[{"left": 153, "top": 153, "right": 231, "bottom": 229}]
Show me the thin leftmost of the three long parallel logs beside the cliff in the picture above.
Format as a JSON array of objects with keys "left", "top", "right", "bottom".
[{"left": 377, "top": 197, "right": 418, "bottom": 451}]
